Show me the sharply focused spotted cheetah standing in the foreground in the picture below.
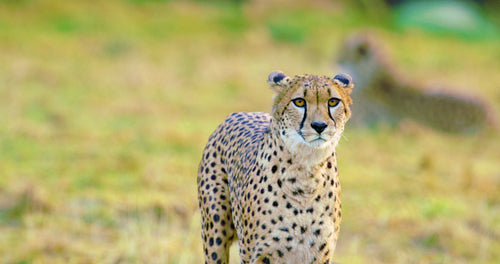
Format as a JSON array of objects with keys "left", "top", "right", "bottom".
[{"left": 197, "top": 71, "right": 354, "bottom": 264}]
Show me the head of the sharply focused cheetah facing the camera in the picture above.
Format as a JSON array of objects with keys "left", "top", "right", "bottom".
[{"left": 268, "top": 71, "right": 354, "bottom": 159}]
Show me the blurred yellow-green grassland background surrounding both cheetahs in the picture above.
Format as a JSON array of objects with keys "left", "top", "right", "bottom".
[{"left": 0, "top": 0, "right": 500, "bottom": 263}]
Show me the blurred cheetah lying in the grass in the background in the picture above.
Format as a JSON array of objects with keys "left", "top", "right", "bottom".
[{"left": 336, "top": 32, "right": 496, "bottom": 134}]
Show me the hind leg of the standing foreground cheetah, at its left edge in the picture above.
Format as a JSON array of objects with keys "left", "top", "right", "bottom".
[{"left": 198, "top": 152, "right": 236, "bottom": 264}]
